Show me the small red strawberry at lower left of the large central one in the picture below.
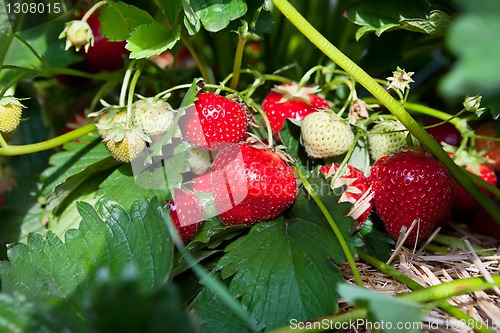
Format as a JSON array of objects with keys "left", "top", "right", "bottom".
[{"left": 167, "top": 188, "right": 205, "bottom": 242}]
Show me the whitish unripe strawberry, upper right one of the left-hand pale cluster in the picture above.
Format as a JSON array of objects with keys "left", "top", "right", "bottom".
[{"left": 132, "top": 97, "right": 175, "bottom": 136}]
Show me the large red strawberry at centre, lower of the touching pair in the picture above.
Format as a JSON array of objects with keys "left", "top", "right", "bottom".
[{"left": 212, "top": 142, "right": 297, "bottom": 225}]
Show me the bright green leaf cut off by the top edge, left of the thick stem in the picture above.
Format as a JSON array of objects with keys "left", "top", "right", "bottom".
[{"left": 182, "top": 0, "right": 247, "bottom": 35}]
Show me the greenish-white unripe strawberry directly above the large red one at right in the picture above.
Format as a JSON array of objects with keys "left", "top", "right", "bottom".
[{"left": 368, "top": 120, "right": 414, "bottom": 161}]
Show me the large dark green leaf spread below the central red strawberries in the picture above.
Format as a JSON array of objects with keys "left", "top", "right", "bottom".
[{"left": 201, "top": 218, "right": 342, "bottom": 329}]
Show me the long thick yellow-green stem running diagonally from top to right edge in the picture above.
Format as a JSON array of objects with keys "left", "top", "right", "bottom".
[{"left": 273, "top": 0, "right": 500, "bottom": 224}]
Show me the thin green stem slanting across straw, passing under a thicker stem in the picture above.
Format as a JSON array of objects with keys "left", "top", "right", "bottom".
[{"left": 358, "top": 250, "right": 493, "bottom": 333}]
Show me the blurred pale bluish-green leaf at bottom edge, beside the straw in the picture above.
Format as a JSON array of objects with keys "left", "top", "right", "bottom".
[{"left": 338, "top": 283, "right": 424, "bottom": 333}]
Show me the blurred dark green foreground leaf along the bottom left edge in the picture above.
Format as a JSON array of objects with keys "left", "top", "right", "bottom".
[{"left": 0, "top": 269, "right": 197, "bottom": 333}]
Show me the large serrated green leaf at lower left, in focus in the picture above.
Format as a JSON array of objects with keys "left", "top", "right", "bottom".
[{"left": 0, "top": 200, "right": 173, "bottom": 302}]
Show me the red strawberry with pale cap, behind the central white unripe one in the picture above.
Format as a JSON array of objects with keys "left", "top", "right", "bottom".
[{"left": 262, "top": 83, "right": 330, "bottom": 137}]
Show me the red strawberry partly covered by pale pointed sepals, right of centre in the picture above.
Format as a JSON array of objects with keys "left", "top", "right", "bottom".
[{"left": 319, "top": 163, "right": 373, "bottom": 228}]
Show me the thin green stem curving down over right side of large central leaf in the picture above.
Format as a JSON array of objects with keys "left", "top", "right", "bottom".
[{"left": 294, "top": 167, "right": 364, "bottom": 287}]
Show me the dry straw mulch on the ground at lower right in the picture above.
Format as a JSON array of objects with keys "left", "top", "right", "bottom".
[{"left": 340, "top": 224, "right": 500, "bottom": 333}]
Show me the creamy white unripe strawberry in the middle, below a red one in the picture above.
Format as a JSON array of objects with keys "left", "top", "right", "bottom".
[{"left": 301, "top": 111, "right": 354, "bottom": 158}]
